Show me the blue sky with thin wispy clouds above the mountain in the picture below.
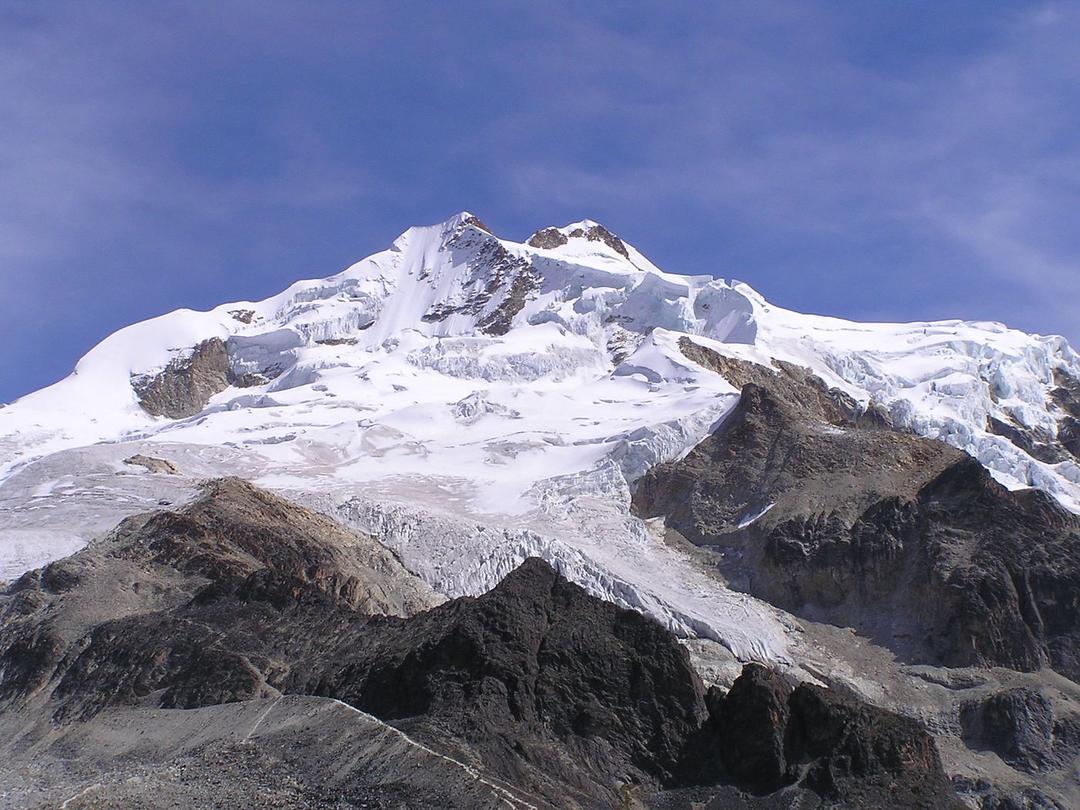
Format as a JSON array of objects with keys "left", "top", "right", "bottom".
[{"left": 0, "top": 0, "right": 1080, "bottom": 401}]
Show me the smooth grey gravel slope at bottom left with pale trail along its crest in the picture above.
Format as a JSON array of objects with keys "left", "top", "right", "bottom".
[{"left": 0, "top": 696, "right": 536, "bottom": 810}]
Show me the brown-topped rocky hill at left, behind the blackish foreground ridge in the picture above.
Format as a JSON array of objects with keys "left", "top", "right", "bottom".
[{"left": 0, "top": 478, "right": 438, "bottom": 714}]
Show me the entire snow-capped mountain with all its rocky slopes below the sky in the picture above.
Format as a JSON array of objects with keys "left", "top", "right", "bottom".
[{"left": 0, "top": 212, "right": 1080, "bottom": 810}]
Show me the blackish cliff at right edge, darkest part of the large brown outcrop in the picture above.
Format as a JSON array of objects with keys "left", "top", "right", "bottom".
[{"left": 899, "top": 459, "right": 1080, "bottom": 680}]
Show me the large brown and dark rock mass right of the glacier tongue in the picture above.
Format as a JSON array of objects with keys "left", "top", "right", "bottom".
[{"left": 634, "top": 339, "right": 1080, "bottom": 679}]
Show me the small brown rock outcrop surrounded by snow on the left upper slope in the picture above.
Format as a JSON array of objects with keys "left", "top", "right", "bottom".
[{"left": 132, "top": 338, "right": 229, "bottom": 419}]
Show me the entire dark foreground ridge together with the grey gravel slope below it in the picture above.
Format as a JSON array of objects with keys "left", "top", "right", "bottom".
[{"left": 0, "top": 480, "right": 959, "bottom": 810}]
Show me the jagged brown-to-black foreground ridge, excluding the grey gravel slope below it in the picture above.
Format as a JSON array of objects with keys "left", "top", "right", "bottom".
[{"left": 0, "top": 480, "right": 955, "bottom": 807}]
